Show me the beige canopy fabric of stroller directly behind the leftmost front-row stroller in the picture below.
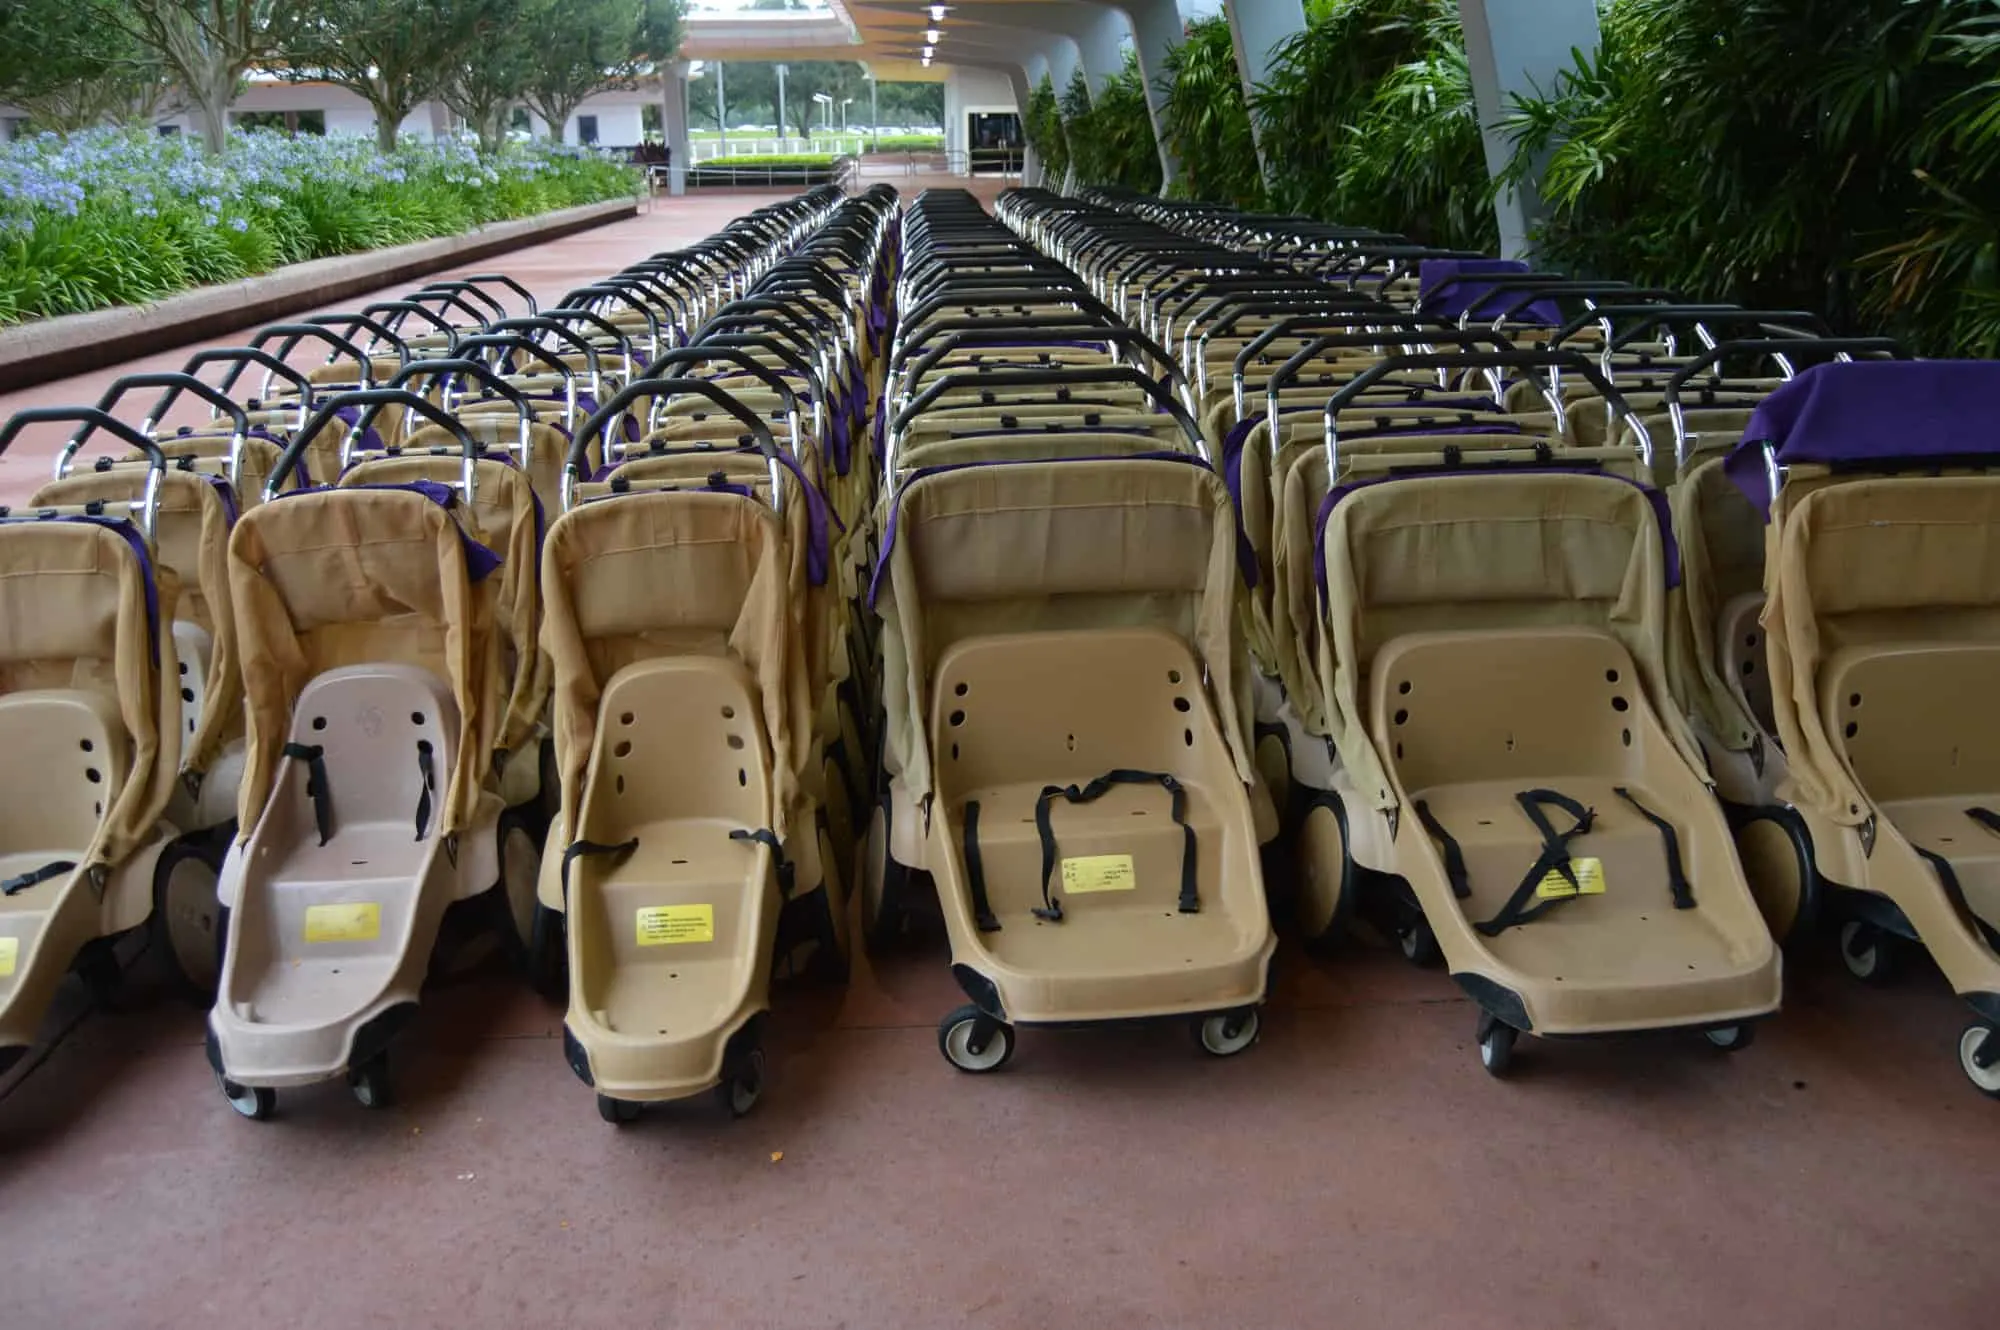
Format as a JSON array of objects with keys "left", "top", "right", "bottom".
[{"left": 28, "top": 466, "right": 244, "bottom": 776}]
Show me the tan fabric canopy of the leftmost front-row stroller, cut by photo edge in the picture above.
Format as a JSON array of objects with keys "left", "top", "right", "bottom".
[{"left": 0, "top": 522, "right": 180, "bottom": 868}]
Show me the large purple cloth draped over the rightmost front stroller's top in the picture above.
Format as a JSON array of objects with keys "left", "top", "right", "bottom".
[{"left": 1722, "top": 360, "right": 2000, "bottom": 516}]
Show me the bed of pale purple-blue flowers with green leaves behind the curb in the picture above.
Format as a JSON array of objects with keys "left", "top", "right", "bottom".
[{"left": 0, "top": 130, "right": 638, "bottom": 324}]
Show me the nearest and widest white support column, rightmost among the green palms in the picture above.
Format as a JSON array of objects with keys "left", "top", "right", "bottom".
[{"left": 1458, "top": 0, "right": 1598, "bottom": 258}]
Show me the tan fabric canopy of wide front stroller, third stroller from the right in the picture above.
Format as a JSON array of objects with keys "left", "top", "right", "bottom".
[{"left": 876, "top": 460, "right": 1254, "bottom": 800}]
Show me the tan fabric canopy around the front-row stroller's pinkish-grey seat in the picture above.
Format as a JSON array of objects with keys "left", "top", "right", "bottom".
[{"left": 230, "top": 490, "right": 502, "bottom": 840}]
